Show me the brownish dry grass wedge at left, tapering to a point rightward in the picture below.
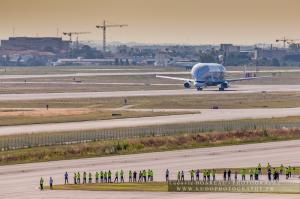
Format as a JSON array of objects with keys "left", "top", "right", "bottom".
[{"left": 0, "top": 108, "right": 182, "bottom": 126}]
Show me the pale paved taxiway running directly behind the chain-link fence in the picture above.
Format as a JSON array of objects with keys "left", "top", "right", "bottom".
[{"left": 0, "top": 107, "right": 300, "bottom": 135}]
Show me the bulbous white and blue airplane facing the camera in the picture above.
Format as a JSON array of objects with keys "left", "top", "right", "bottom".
[{"left": 156, "top": 63, "right": 271, "bottom": 91}]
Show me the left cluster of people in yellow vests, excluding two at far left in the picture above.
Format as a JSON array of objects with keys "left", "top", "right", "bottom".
[{"left": 64, "top": 169, "right": 154, "bottom": 184}]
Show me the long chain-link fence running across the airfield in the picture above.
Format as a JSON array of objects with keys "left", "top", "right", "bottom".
[{"left": 0, "top": 119, "right": 300, "bottom": 151}]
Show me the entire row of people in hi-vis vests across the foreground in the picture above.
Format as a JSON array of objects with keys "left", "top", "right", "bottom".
[{"left": 40, "top": 163, "right": 296, "bottom": 190}]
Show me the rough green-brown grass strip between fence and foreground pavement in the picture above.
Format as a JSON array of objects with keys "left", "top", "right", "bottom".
[{"left": 0, "top": 129, "right": 300, "bottom": 165}]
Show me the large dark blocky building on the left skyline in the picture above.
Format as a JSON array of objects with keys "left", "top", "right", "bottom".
[{"left": 1, "top": 37, "right": 70, "bottom": 55}]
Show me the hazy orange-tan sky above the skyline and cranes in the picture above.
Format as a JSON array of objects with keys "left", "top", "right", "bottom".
[{"left": 0, "top": 0, "right": 300, "bottom": 44}]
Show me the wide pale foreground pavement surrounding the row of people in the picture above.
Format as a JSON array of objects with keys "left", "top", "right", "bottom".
[{"left": 0, "top": 140, "right": 300, "bottom": 199}]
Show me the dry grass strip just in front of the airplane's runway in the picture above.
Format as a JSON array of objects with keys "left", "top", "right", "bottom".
[{"left": 0, "top": 92, "right": 300, "bottom": 109}]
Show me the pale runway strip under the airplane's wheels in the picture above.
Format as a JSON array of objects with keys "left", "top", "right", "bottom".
[{"left": 0, "top": 85, "right": 300, "bottom": 101}]
